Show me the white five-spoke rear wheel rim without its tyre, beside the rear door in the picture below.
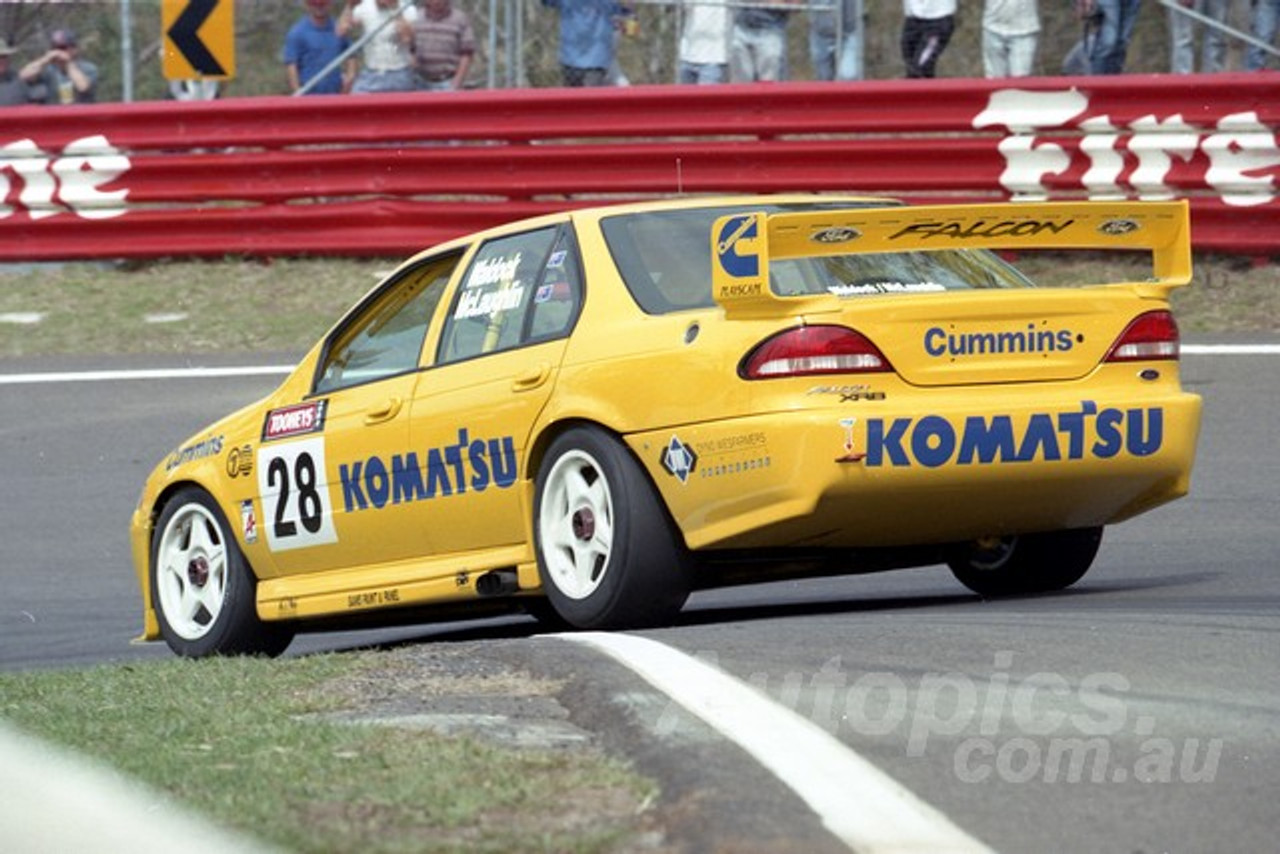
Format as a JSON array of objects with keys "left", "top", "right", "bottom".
[{"left": 538, "top": 448, "right": 613, "bottom": 599}]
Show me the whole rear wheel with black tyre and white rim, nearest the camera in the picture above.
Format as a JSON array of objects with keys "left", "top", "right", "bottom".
[{"left": 534, "top": 428, "right": 690, "bottom": 629}]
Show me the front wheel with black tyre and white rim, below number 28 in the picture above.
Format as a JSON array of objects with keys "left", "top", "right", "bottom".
[{"left": 151, "top": 488, "right": 293, "bottom": 658}]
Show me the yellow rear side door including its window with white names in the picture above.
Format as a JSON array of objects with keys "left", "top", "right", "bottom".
[{"left": 410, "top": 224, "right": 584, "bottom": 553}]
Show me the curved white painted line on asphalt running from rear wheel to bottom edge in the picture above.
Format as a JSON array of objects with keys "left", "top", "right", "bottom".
[{"left": 558, "top": 632, "right": 992, "bottom": 854}]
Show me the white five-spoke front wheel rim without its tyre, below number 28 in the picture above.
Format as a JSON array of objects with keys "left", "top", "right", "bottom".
[{"left": 156, "top": 503, "right": 228, "bottom": 640}]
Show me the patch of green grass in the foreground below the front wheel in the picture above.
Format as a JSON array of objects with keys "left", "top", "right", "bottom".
[{"left": 0, "top": 653, "right": 654, "bottom": 853}]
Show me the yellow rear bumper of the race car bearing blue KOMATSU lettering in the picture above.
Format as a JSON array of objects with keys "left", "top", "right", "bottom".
[{"left": 627, "top": 389, "right": 1201, "bottom": 549}]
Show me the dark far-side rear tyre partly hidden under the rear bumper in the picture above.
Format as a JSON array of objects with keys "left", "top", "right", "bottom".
[{"left": 947, "top": 528, "right": 1102, "bottom": 597}]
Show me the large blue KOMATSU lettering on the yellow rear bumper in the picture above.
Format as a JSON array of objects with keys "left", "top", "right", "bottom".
[{"left": 865, "top": 401, "right": 1165, "bottom": 469}]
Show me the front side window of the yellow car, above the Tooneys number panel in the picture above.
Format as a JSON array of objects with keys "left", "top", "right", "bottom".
[{"left": 315, "top": 248, "right": 458, "bottom": 393}]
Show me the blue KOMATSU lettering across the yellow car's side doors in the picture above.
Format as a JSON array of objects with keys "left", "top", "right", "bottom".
[{"left": 338, "top": 428, "right": 516, "bottom": 513}]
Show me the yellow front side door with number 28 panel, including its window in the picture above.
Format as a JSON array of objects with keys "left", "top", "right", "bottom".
[{"left": 257, "top": 254, "right": 460, "bottom": 575}]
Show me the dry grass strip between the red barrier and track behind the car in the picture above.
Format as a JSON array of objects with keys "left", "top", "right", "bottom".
[{"left": 0, "top": 254, "right": 1280, "bottom": 359}]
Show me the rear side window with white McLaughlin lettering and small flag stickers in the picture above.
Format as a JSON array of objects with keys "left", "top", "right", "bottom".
[{"left": 439, "top": 227, "right": 581, "bottom": 364}]
